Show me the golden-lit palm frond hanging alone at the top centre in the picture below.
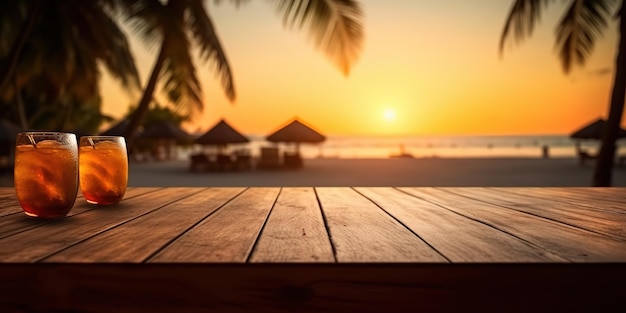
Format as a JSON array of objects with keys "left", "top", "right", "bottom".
[{"left": 274, "top": 0, "right": 364, "bottom": 75}]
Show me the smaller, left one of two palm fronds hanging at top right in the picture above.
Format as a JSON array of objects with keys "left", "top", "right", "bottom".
[{"left": 500, "top": 0, "right": 553, "bottom": 53}]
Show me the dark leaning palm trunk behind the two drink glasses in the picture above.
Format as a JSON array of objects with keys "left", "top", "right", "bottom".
[{"left": 124, "top": 39, "right": 167, "bottom": 148}]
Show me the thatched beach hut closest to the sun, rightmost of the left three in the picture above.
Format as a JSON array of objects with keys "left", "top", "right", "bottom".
[{"left": 265, "top": 119, "right": 326, "bottom": 168}]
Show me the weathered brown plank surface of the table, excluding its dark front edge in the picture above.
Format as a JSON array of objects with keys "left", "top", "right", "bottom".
[{"left": 0, "top": 187, "right": 626, "bottom": 263}]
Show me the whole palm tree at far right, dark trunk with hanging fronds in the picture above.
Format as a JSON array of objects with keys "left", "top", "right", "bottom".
[{"left": 500, "top": 0, "right": 626, "bottom": 187}]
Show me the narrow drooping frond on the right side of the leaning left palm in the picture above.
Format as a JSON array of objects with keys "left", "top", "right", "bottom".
[{"left": 188, "top": 1, "right": 235, "bottom": 101}]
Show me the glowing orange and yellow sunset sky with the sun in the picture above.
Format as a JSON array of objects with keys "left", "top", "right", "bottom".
[{"left": 102, "top": 0, "right": 616, "bottom": 135}]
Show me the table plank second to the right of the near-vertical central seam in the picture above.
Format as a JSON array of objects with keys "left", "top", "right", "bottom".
[{"left": 356, "top": 188, "right": 566, "bottom": 262}]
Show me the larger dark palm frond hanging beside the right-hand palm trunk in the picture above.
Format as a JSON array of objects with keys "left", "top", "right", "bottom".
[{"left": 556, "top": 0, "right": 617, "bottom": 73}]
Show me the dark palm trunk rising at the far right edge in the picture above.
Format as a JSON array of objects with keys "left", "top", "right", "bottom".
[{"left": 593, "top": 5, "right": 626, "bottom": 187}]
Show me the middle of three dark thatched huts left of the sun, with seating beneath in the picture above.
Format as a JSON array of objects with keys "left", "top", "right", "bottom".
[{"left": 191, "top": 119, "right": 251, "bottom": 170}]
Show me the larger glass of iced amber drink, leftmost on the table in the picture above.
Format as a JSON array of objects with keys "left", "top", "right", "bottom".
[{"left": 14, "top": 132, "right": 78, "bottom": 218}]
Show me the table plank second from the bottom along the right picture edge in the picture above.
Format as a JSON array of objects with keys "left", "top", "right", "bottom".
[{"left": 462, "top": 188, "right": 626, "bottom": 241}]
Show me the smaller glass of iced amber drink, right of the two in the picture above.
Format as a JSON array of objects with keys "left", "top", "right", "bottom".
[{"left": 78, "top": 136, "right": 128, "bottom": 205}]
